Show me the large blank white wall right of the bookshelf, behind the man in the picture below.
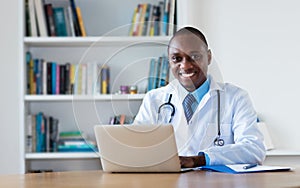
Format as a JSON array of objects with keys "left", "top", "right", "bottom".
[{"left": 178, "top": 0, "right": 300, "bottom": 151}]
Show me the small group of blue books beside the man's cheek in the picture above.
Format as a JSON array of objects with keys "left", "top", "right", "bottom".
[{"left": 148, "top": 55, "right": 170, "bottom": 91}]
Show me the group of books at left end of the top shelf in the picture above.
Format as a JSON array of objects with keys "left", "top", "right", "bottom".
[{"left": 25, "top": 0, "right": 86, "bottom": 37}]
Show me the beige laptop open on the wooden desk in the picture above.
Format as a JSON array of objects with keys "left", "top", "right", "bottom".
[{"left": 94, "top": 124, "right": 191, "bottom": 172}]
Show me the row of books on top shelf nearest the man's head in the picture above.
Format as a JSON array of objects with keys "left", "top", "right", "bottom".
[{"left": 129, "top": 0, "right": 176, "bottom": 36}]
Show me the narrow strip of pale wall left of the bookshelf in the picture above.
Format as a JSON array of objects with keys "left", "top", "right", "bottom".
[{"left": 0, "top": 0, "right": 22, "bottom": 174}]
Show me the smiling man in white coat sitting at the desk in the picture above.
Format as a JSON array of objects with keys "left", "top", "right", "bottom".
[{"left": 134, "top": 27, "right": 265, "bottom": 167}]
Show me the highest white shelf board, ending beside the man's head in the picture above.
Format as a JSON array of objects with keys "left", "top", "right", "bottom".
[{"left": 24, "top": 36, "right": 170, "bottom": 47}]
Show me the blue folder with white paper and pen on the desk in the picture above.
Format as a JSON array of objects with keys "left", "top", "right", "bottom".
[{"left": 197, "top": 164, "right": 292, "bottom": 174}]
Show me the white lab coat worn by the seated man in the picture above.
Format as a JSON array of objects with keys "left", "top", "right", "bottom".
[{"left": 134, "top": 77, "right": 266, "bottom": 165}]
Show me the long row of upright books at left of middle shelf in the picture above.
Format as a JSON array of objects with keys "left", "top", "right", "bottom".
[{"left": 26, "top": 52, "right": 103, "bottom": 95}]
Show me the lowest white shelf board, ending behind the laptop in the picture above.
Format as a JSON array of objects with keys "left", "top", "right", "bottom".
[{"left": 25, "top": 152, "right": 99, "bottom": 160}]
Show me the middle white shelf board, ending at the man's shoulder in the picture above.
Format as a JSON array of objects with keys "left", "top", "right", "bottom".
[{"left": 25, "top": 94, "right": 145, "bottom": 102}]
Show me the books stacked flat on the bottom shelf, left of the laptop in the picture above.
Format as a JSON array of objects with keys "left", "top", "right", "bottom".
[{"left": 58, "top": 131, "right": 96, "bottom": 152}]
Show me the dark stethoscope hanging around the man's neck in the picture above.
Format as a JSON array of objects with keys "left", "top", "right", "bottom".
[{"left": 158, "top": 90, "right": 225, "bottom": 146}]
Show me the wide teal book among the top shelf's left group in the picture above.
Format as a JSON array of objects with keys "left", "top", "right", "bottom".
[{"left": 53, "top": 7, "right": 68, "bottom": 36}]
